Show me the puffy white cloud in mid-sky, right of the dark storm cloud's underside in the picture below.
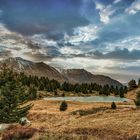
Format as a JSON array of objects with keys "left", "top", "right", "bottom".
[{"left": 64, "top": 24, "right": 99, "bottom": 45}]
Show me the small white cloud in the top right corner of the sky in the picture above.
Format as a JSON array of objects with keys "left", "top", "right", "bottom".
[{"left": 125, "top": 0, "right": 140, "bottom": 15}]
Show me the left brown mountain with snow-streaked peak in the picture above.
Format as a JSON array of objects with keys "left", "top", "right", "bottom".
[{"left": 0, "top": 57, "right": 67, "bottom": 82}]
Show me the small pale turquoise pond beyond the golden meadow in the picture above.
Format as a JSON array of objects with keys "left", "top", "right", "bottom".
[{"left": 44, "top": 96, "right": 130, "bottom": 102}]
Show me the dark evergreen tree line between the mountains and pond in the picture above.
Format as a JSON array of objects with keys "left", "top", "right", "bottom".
[{"left": 15, "top": 73, "right": 127, "bottom": 97}]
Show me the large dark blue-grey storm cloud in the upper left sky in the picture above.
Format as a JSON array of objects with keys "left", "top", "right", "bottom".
[{"left": 0, "top": 0, "right": 89, "bottom": 36}]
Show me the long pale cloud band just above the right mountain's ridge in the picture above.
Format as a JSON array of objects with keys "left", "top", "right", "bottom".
[{"left": 50, "top": 57, "right": 116, "bottom": 72}]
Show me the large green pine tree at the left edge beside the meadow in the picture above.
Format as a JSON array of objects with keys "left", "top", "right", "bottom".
[{"left": 0, "top": 69, "right": 32, "bottom": 123}]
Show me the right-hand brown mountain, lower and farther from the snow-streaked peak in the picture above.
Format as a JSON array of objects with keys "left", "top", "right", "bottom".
[{"left": 61, "top": 69, "right": 122, "bottom": 87}]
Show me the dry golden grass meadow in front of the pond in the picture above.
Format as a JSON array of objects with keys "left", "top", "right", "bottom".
[{"left": 24, "top": 100, "right": 140, "bottom": 140}]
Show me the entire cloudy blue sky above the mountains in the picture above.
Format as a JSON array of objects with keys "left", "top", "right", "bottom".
[{"left": 0, "top": 0, "right": 140, "bottom": 83}]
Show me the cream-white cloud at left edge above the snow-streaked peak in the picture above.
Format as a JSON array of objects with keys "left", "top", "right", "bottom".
[{"left": 0, "top": 23, "right": 32, "bottom": 58}]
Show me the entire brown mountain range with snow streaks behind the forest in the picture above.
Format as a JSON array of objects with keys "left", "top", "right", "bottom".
[{"left": 0, "top": 57, "right": 122, "bottom": 87}]
